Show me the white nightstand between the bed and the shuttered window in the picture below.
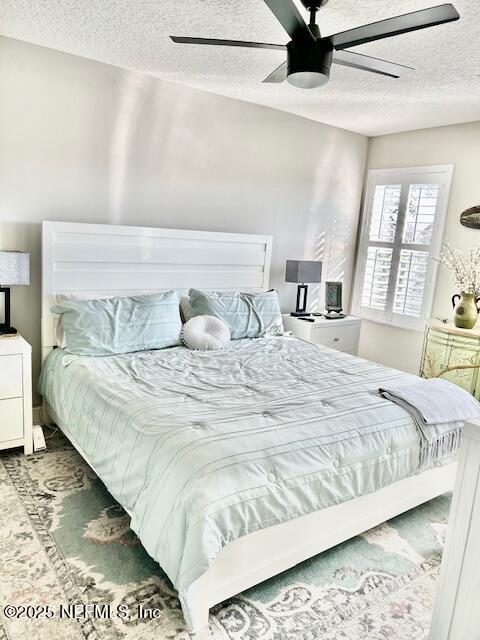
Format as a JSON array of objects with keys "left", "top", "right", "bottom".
[{"left": 282, "top": 313, "right": 362, "bottom": 356}]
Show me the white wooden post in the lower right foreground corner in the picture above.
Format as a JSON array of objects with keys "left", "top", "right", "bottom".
[{"left": 429, "top": 421, "right": 480, "bottom": 640}]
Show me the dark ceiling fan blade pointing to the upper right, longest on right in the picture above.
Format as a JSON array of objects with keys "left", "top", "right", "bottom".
[{"left": 329, "top": 4, "right": 460, "bottom": 49}]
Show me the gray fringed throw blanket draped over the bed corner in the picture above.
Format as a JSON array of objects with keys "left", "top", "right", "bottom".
[{"left": 379, "top": 378, "right": 480, "bottom": 463}]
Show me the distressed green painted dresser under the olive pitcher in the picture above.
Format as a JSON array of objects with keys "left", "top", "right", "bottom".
[{"left": 420, "top": 320, "right": 480, "bottom": 400}]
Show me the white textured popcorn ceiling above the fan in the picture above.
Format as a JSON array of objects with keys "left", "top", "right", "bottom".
[{"left": 0, "top": 0, "right": 480, "bottom": 135}]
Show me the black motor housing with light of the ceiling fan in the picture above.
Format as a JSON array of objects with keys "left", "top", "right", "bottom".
[{"left": 287, "top": 40, "right": 333, "bottom": 89}]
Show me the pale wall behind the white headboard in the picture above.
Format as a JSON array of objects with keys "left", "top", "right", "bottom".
[{"left": 0, "top": 38, "right": 368, "bottom": 400}]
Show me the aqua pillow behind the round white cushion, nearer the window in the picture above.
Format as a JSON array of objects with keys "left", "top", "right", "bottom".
[{"left": 189, "top": 289, "right": 283, "bottom": 340}]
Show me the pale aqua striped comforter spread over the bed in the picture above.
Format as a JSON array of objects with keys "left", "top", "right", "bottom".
[{"left": 39, "top": 336, "right": 454, "bottom": 593}]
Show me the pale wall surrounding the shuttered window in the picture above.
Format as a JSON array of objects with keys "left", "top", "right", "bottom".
[{"left": 360, "top": 122, "right": 480, "bottom": 373}]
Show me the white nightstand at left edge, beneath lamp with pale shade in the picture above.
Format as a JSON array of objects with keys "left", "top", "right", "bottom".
[{"left": 0, "top": 335, "right": 33, "bottom": 455}]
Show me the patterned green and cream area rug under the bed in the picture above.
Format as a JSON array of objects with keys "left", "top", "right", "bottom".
[{"left": 0, "top": 438, "right": 450, "bottom": 640}]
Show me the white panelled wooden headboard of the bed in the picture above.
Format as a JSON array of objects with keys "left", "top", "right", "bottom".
[{"left": 42, "top": 222, "right": 272, "bottom": 357}]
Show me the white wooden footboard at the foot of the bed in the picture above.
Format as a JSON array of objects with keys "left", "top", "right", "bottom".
[{"left": 180, "top": 463, "right": 457, "bottom": 637}]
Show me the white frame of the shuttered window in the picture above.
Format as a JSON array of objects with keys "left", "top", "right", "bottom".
[{"left": 352, "top": 164, "right": 454, "bottom": 331}]
